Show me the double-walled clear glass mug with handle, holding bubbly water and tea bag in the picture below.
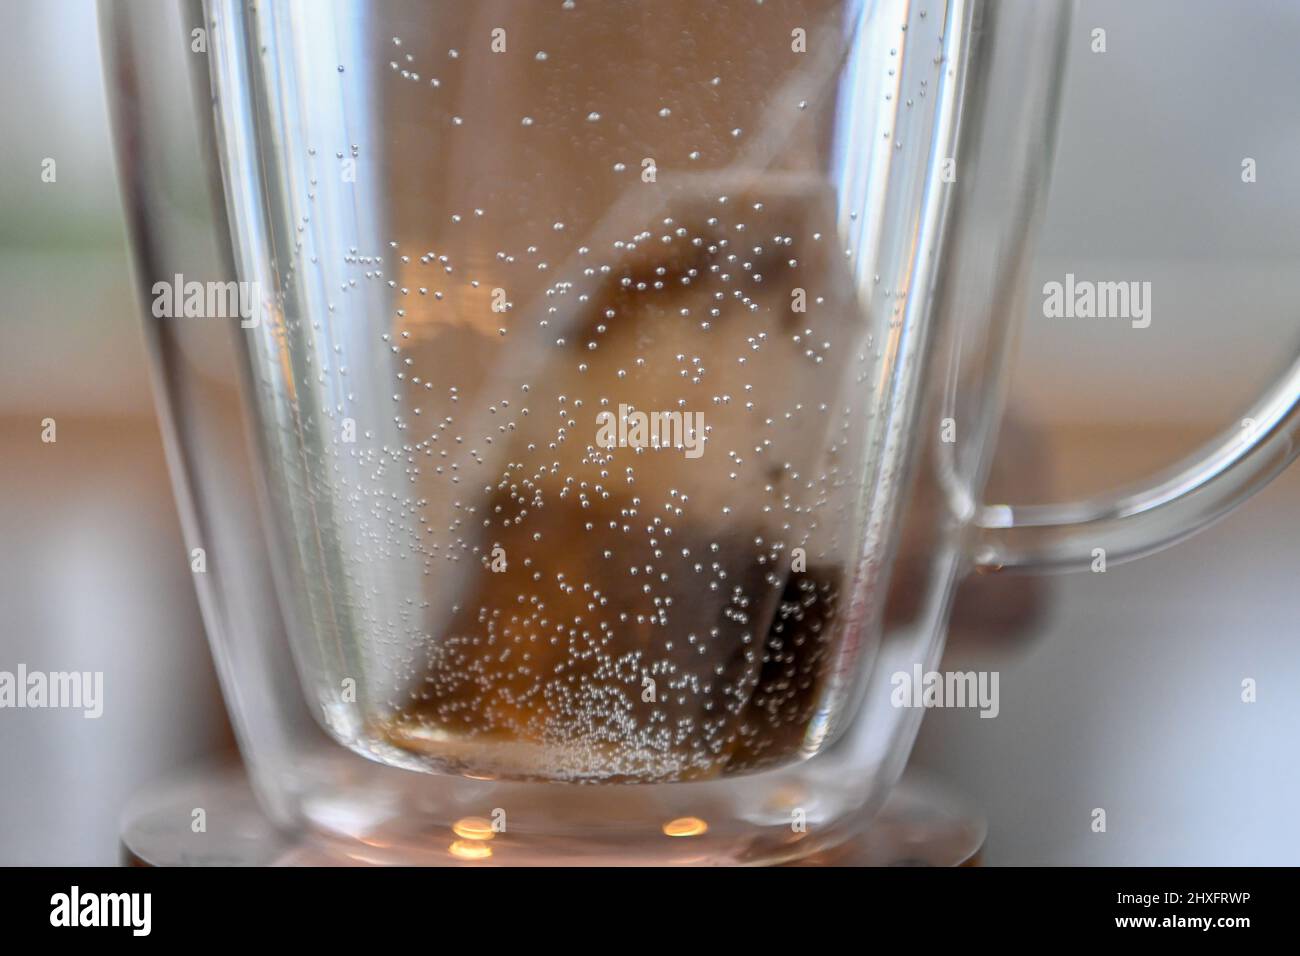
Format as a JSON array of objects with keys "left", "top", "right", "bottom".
[{"left": 101, "top": 0, "right": 1300, "bottom": 864}]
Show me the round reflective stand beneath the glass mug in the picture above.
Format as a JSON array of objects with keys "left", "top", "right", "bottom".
[{"left": 121, "top": 765, "right": 987, "bottom": 866}]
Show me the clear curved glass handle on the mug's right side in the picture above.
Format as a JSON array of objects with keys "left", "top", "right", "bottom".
[{"left": 972, "top": 356, "right": 1300, "bottom": 571}]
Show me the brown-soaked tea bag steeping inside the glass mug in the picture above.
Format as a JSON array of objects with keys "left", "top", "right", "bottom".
[{"left": 389, "top": 183, "right": 854, "bottom": 780}]
